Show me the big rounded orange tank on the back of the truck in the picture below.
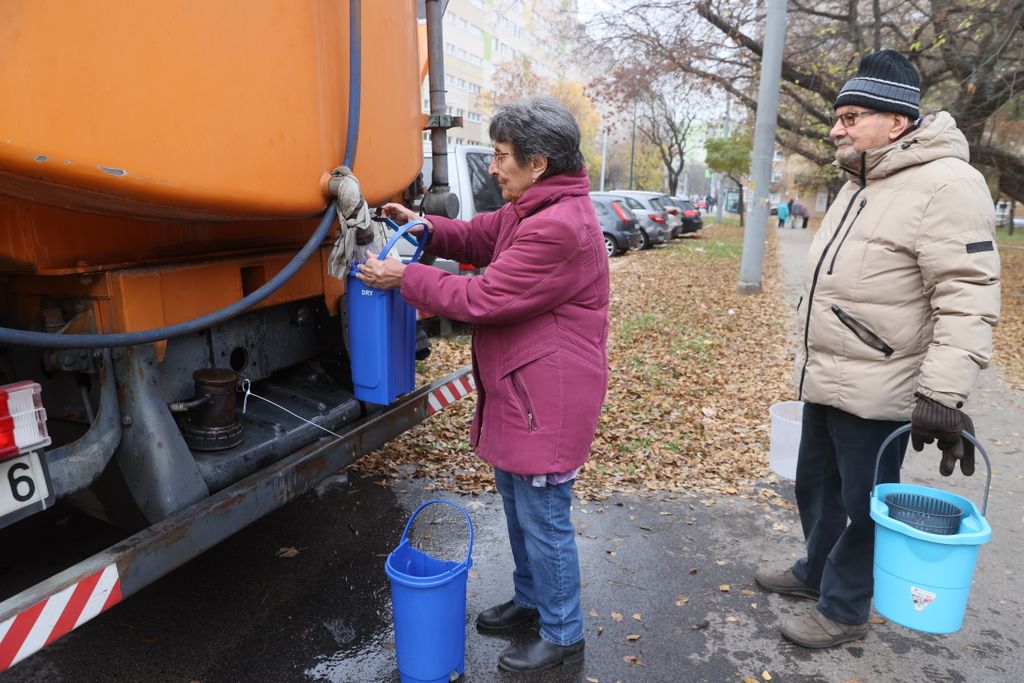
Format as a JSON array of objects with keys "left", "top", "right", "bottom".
[{"left": 0, "top": 0, "right": 423, "bottom": 274}]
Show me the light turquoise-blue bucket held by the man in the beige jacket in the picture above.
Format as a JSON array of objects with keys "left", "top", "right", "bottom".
[{"left": 870, "top": 425, "right": 992, "bottom": 633}]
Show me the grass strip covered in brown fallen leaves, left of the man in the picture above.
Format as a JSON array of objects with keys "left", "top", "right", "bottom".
[{"left": 355, "top": 227, "right": 792, "bottom": 499}]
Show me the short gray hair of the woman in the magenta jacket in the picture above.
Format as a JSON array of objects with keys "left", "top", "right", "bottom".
[{"left": 488, "top": 95, "right": 584, "bottom": 178}]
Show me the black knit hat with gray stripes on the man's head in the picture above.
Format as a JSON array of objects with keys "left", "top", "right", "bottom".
[{"left": 833, "top": 50, "right": 921, "bottom": 121}]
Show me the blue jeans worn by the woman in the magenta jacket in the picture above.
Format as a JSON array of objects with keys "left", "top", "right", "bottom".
[{"left": 495, "top": 469, "right": 583, "bottom": 645}]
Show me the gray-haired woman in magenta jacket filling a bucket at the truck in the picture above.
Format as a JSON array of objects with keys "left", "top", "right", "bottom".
[{"left": 359, "top": 97, "right": 608, "bottom": 671}]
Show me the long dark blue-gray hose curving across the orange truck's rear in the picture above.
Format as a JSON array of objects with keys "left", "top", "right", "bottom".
[{"left": 0, "top": 0, "right": 362, "bottom": 348}]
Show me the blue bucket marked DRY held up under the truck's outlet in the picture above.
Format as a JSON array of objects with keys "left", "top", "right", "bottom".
[{"left": 345, "top": 219, "right": 429, "bottom": 405}]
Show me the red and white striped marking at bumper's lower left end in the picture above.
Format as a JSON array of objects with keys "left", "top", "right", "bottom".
[{"left": 0, "top": 564, "right": 121, "bottom": 672}]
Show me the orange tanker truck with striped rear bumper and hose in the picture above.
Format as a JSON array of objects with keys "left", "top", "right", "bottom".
[{"left": 0, "top": 0, "right": 472, "bottom": 672}]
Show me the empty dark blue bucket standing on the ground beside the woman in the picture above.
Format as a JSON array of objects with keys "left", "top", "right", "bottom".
[{"left": 384, "top": 501, "right": 473, "bottom": 683}]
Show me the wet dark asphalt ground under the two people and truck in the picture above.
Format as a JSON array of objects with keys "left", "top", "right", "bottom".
[{"left": 0, "top": 227, "right": 1024, "bottom": 683}]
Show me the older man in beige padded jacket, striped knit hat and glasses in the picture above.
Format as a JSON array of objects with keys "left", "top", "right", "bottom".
[{"left": 756, "top": 50, "right": 999, "bottom": 648}]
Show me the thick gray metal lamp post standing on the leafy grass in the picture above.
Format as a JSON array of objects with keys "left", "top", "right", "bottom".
[{"left": 737, "top": 0, "right": 785, "bottom": 294}]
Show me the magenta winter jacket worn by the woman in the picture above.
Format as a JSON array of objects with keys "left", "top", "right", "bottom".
[{"left": 401, "top": 170, "right": 608, "bottom": 474}]
